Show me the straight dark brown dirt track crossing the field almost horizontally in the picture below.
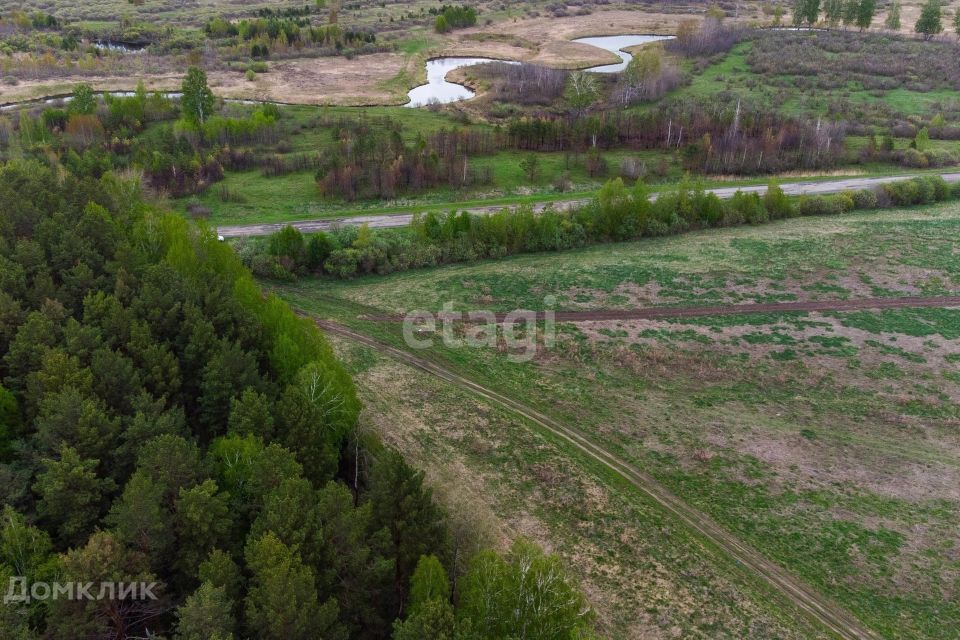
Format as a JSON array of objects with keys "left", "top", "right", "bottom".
[{"left": 365, "top": 296, "right": 960, "bottom": 323}]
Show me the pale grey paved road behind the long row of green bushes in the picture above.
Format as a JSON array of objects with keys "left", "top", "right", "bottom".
[{"left": 217, "top": 173, "right": 960, "bottom": 238}]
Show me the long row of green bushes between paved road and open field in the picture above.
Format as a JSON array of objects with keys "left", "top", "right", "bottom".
[{"left": 246, "top": 177, "right": 960, "bottom": 280}]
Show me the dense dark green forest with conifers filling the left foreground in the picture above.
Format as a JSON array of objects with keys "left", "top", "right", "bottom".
[{"left": 0, "top": 156, "right": 590, "bottom": 640}]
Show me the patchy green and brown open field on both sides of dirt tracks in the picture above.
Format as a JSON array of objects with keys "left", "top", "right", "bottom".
[{"left": 279, "top": 204, "right": 960, "bottom": 639}]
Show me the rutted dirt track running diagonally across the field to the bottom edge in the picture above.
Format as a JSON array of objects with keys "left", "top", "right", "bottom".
[{"left": 314, "top": 316, "right": 884, "bottom": 640}]
